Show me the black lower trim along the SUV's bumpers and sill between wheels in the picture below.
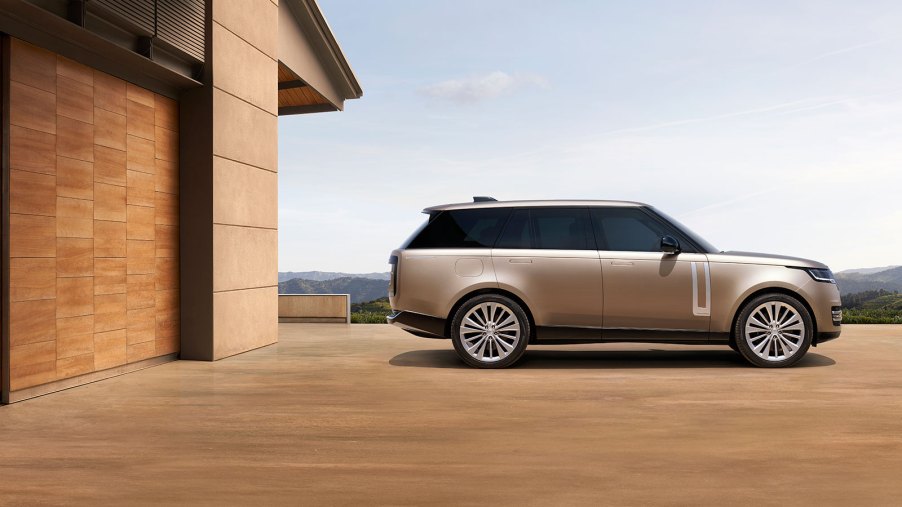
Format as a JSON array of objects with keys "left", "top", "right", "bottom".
[{"left": 386, "top": 311, "right": 841, "bottom": 345}]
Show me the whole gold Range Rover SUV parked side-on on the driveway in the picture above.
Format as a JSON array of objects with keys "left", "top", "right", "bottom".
[{"left": 388, "top": 197, "right": 842, "bottom": 368}]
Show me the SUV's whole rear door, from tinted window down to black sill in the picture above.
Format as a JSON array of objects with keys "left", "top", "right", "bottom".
[{"left": 492, "top": 207, "right": 603, "bottom": 339}]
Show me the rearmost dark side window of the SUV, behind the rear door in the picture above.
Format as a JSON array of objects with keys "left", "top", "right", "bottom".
[{"left": 407, "top": 208, "right": 511, "bottom": 248}]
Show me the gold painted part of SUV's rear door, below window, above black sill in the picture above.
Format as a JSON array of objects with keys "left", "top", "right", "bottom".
[{"left": 492, "top": 248, "right": 604, "bottom": 335}]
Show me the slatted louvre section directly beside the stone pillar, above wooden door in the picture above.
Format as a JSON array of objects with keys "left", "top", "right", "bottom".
[{"left": 157, "top": 0, "right": 205, "bottom": 62}]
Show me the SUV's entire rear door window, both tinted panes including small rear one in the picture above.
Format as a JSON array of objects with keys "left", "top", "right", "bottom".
[{"left": 495, "top": 208, "right": 595, "bottom": 250}]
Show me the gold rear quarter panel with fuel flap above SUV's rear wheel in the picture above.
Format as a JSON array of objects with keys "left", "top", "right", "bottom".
[{"left": 390, "top": 248, "right": 498, "bottom": 319}]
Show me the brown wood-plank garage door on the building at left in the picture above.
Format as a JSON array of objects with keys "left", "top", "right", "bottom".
[{"left": 9, "top": 39, "right": 179, "bottom": 391}]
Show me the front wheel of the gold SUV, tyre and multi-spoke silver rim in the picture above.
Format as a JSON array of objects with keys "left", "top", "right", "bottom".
[{"left": 733, "top": 293, "right": 814, "bottom": 368}]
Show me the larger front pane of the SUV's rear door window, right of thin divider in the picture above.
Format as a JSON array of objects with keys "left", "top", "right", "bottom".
[{"left": 530, "top": 208, "right": 595, "bottom": 250}]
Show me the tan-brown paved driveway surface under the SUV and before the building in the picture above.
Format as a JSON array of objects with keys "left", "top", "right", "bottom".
[{"left": 0, "top": 324, "right": 902, "bottom": 505}]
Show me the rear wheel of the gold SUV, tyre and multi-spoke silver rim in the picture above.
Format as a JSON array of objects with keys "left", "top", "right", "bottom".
[{"left": 451, "top": 294, "right": 530, "bottom": 368}]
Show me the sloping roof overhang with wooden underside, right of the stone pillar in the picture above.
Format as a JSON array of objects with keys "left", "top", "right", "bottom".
[{"left": 278, "top": 0, "right": 363, "bottom": 115}]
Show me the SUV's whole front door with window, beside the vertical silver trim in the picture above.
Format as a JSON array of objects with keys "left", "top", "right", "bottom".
[{"left": 591, "top": 207, "right": 711, "bottom": 341}]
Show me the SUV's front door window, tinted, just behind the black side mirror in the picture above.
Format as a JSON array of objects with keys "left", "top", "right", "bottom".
[{"left": 589, "top": 208, "right": 679, "bottom": 252}]
